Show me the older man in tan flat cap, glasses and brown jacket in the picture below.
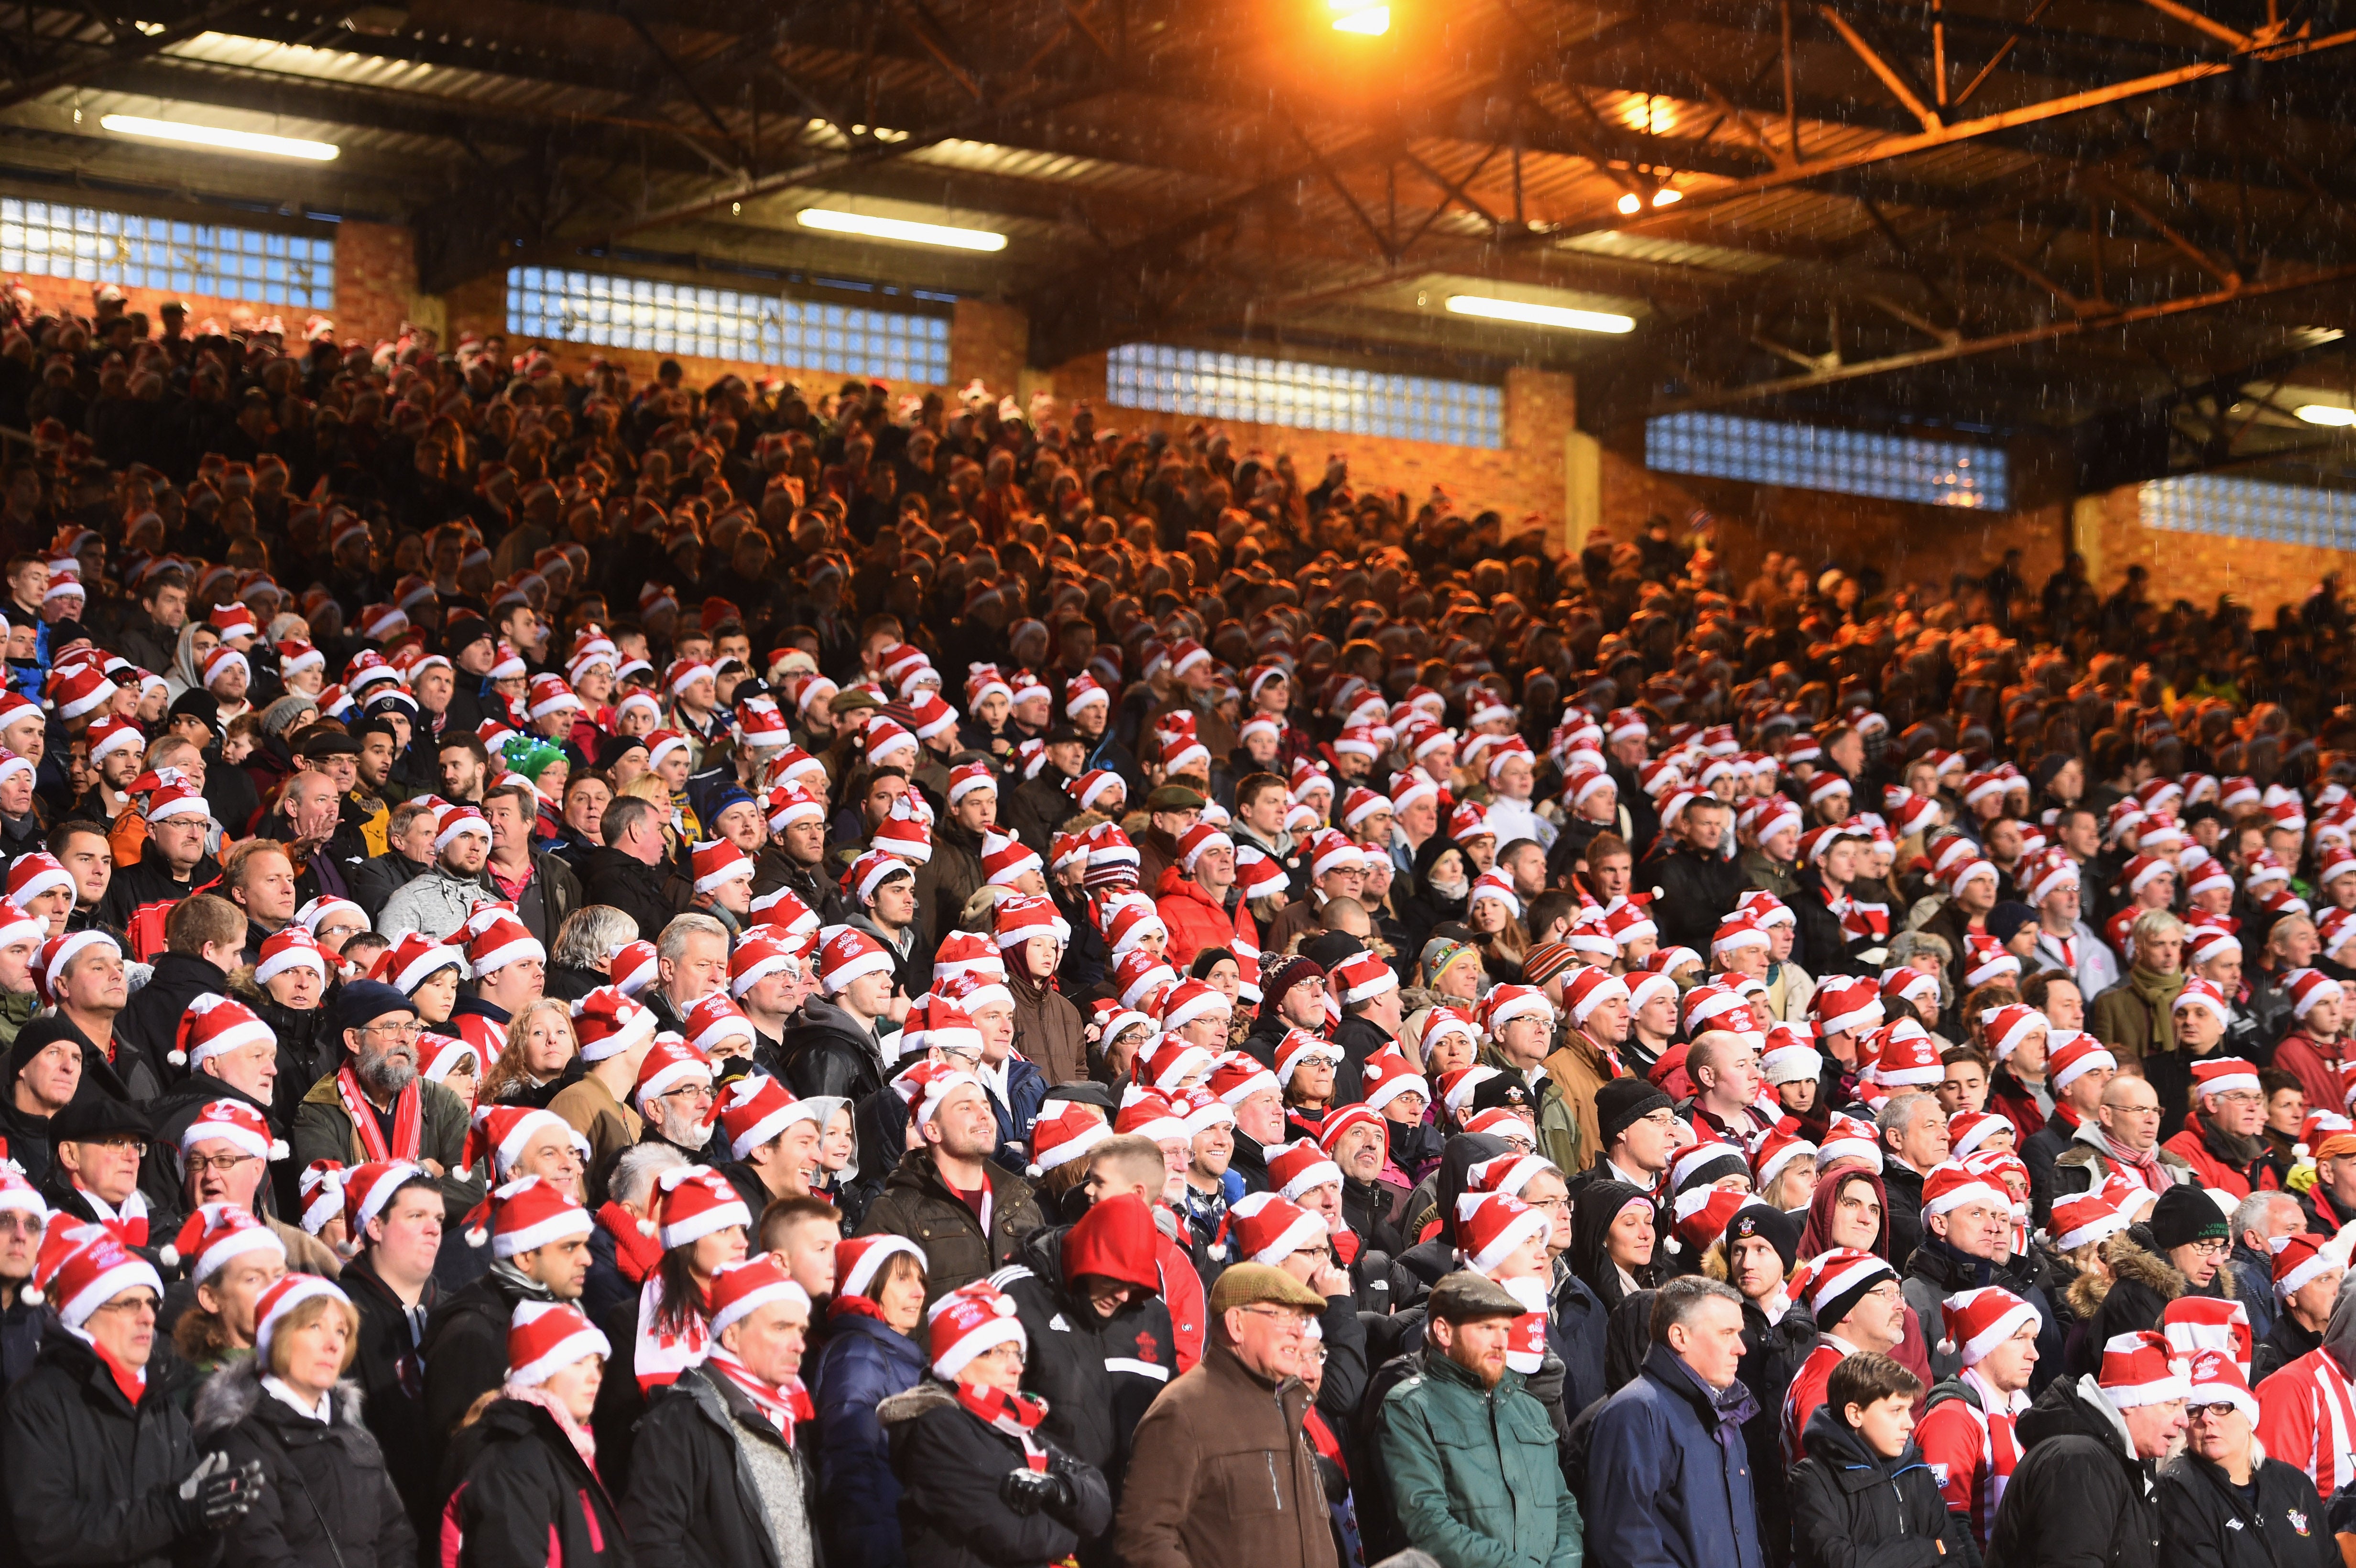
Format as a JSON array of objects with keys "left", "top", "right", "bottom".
[{"left": 1112, "top": 1262, "right": 1338, "bottom": 1568}]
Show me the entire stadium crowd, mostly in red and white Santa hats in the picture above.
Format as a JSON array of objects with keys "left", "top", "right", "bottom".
[{"left": 0, "top": 292, "right": 2356, "bottom": 1568}]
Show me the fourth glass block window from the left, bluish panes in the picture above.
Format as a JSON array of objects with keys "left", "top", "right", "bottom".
[{"left": 1645, "top": 414, "right": 2012, "bottom": 511}]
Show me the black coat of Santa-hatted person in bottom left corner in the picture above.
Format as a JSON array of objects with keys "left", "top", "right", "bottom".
[{"left": 0, "top": 1321, "right": 219, "bottom": 1568}]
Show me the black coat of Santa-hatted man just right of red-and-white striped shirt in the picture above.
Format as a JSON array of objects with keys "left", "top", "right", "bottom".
[{"left": 1986, "top": 1377, "right": 2160, "bottom": 1568}]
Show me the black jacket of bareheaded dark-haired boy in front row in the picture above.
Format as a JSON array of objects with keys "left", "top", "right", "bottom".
[{"left": 1790, "top": 1401, "right": 1967, "bottom": 1568}]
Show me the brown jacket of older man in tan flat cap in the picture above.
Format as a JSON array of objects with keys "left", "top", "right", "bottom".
[{"left": 1112, "top": 1328, "right": 1333, "bottom": 1568}]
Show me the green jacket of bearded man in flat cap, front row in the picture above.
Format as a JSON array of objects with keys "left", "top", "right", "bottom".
[{"left": 1381, "top": 1344, "right": 1586, "bottom": 1568}]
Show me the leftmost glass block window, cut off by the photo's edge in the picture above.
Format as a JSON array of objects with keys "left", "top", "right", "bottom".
[{"left": 0, "top": 198, "right": 335, "bottom": 311}]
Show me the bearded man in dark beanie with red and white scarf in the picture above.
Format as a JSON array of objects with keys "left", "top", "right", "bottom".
[{"left": 292, "top": 980, "right": 483, "bottom": 1224}]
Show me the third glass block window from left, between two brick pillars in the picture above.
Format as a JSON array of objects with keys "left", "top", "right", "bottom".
[{"left": 1105, "top": 344, "right": 1505, "bottom": 447}]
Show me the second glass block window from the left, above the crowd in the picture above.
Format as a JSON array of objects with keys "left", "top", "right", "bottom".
[{"left": 507, "top": 266, "right": 949, "bottom": 386}]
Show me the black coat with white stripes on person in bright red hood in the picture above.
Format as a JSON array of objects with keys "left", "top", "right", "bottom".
[{"left": 990, "top": 1224, "right": 1178, "bottom": 1476}]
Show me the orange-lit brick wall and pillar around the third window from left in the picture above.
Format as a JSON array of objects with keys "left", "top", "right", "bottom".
[{"left": 1044, "top": 353, "right": 1576, "bottom": 539}]
